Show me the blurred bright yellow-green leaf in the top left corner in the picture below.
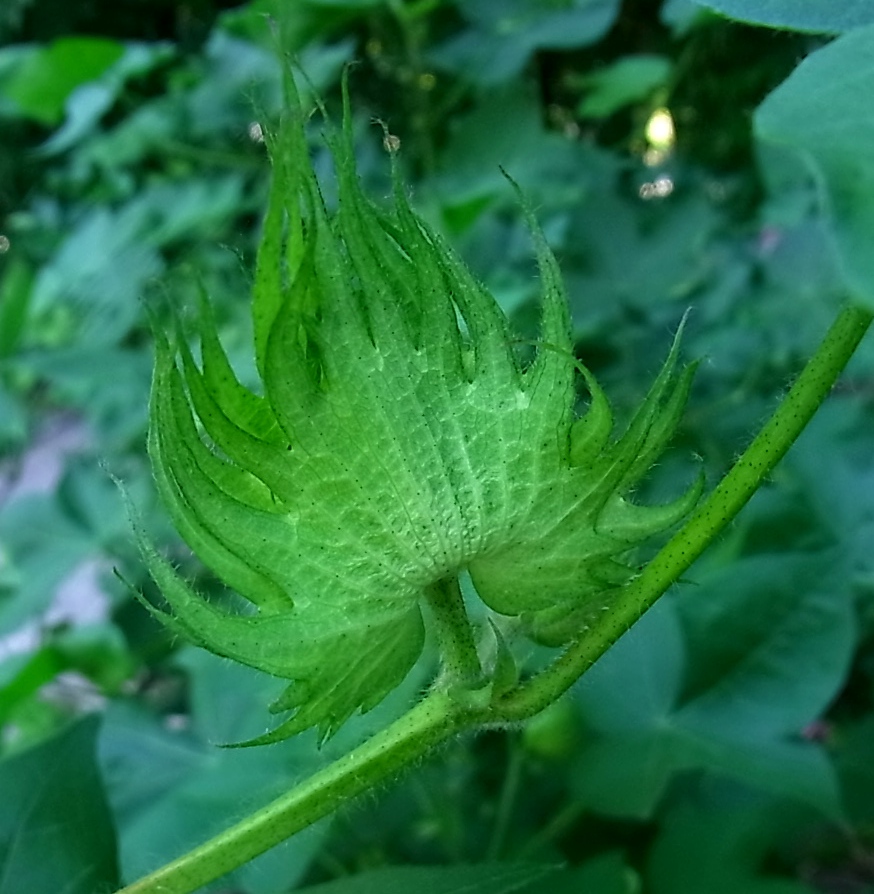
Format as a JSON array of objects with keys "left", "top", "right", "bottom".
[{"left": 3, "top": 37, "right": 124, "bottom": 126}]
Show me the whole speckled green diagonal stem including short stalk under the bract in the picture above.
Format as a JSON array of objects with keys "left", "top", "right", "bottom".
[{"left": 119, "top": 307, "right": 872, "bottom": 894}]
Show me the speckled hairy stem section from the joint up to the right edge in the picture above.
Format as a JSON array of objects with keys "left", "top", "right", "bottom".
[{"left": 493, "top": 305, "right": 872, "bottom": 723}]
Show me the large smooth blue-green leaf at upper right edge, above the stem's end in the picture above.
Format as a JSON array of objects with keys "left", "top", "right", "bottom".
[{"left": 755, "top": 23, "right": 874, "bottom": 307}]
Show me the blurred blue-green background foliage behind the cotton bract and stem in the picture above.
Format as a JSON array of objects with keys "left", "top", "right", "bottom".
[{"left": 0, "top": 0, "right": 874, "bottom": 894}]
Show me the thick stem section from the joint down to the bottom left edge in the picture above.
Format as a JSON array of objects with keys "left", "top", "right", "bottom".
[{"left": 119, "top": 692, "right": 470, "bottom": 894}]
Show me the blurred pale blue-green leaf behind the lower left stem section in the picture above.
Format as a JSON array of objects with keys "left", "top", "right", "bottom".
[{"left": 101, "top": 650, "right": 334, "bottom": 894}]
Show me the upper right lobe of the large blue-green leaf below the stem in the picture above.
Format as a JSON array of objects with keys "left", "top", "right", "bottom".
[{"left": 679, "top": 550, "right": 856, "bottom": 738}]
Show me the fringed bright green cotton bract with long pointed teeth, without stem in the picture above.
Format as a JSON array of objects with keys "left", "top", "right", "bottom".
[{"left": 145, "top": 84, "right": 700, "bottom": 741}]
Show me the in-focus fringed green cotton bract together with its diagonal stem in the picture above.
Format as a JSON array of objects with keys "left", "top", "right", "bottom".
[{"left": 125, "top": 73, "right": 870, "bottom": 894}]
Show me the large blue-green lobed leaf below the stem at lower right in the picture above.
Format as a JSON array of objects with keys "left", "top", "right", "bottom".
[{"left": 574, "top": 552, "right": 855, "bottom": 817}]
